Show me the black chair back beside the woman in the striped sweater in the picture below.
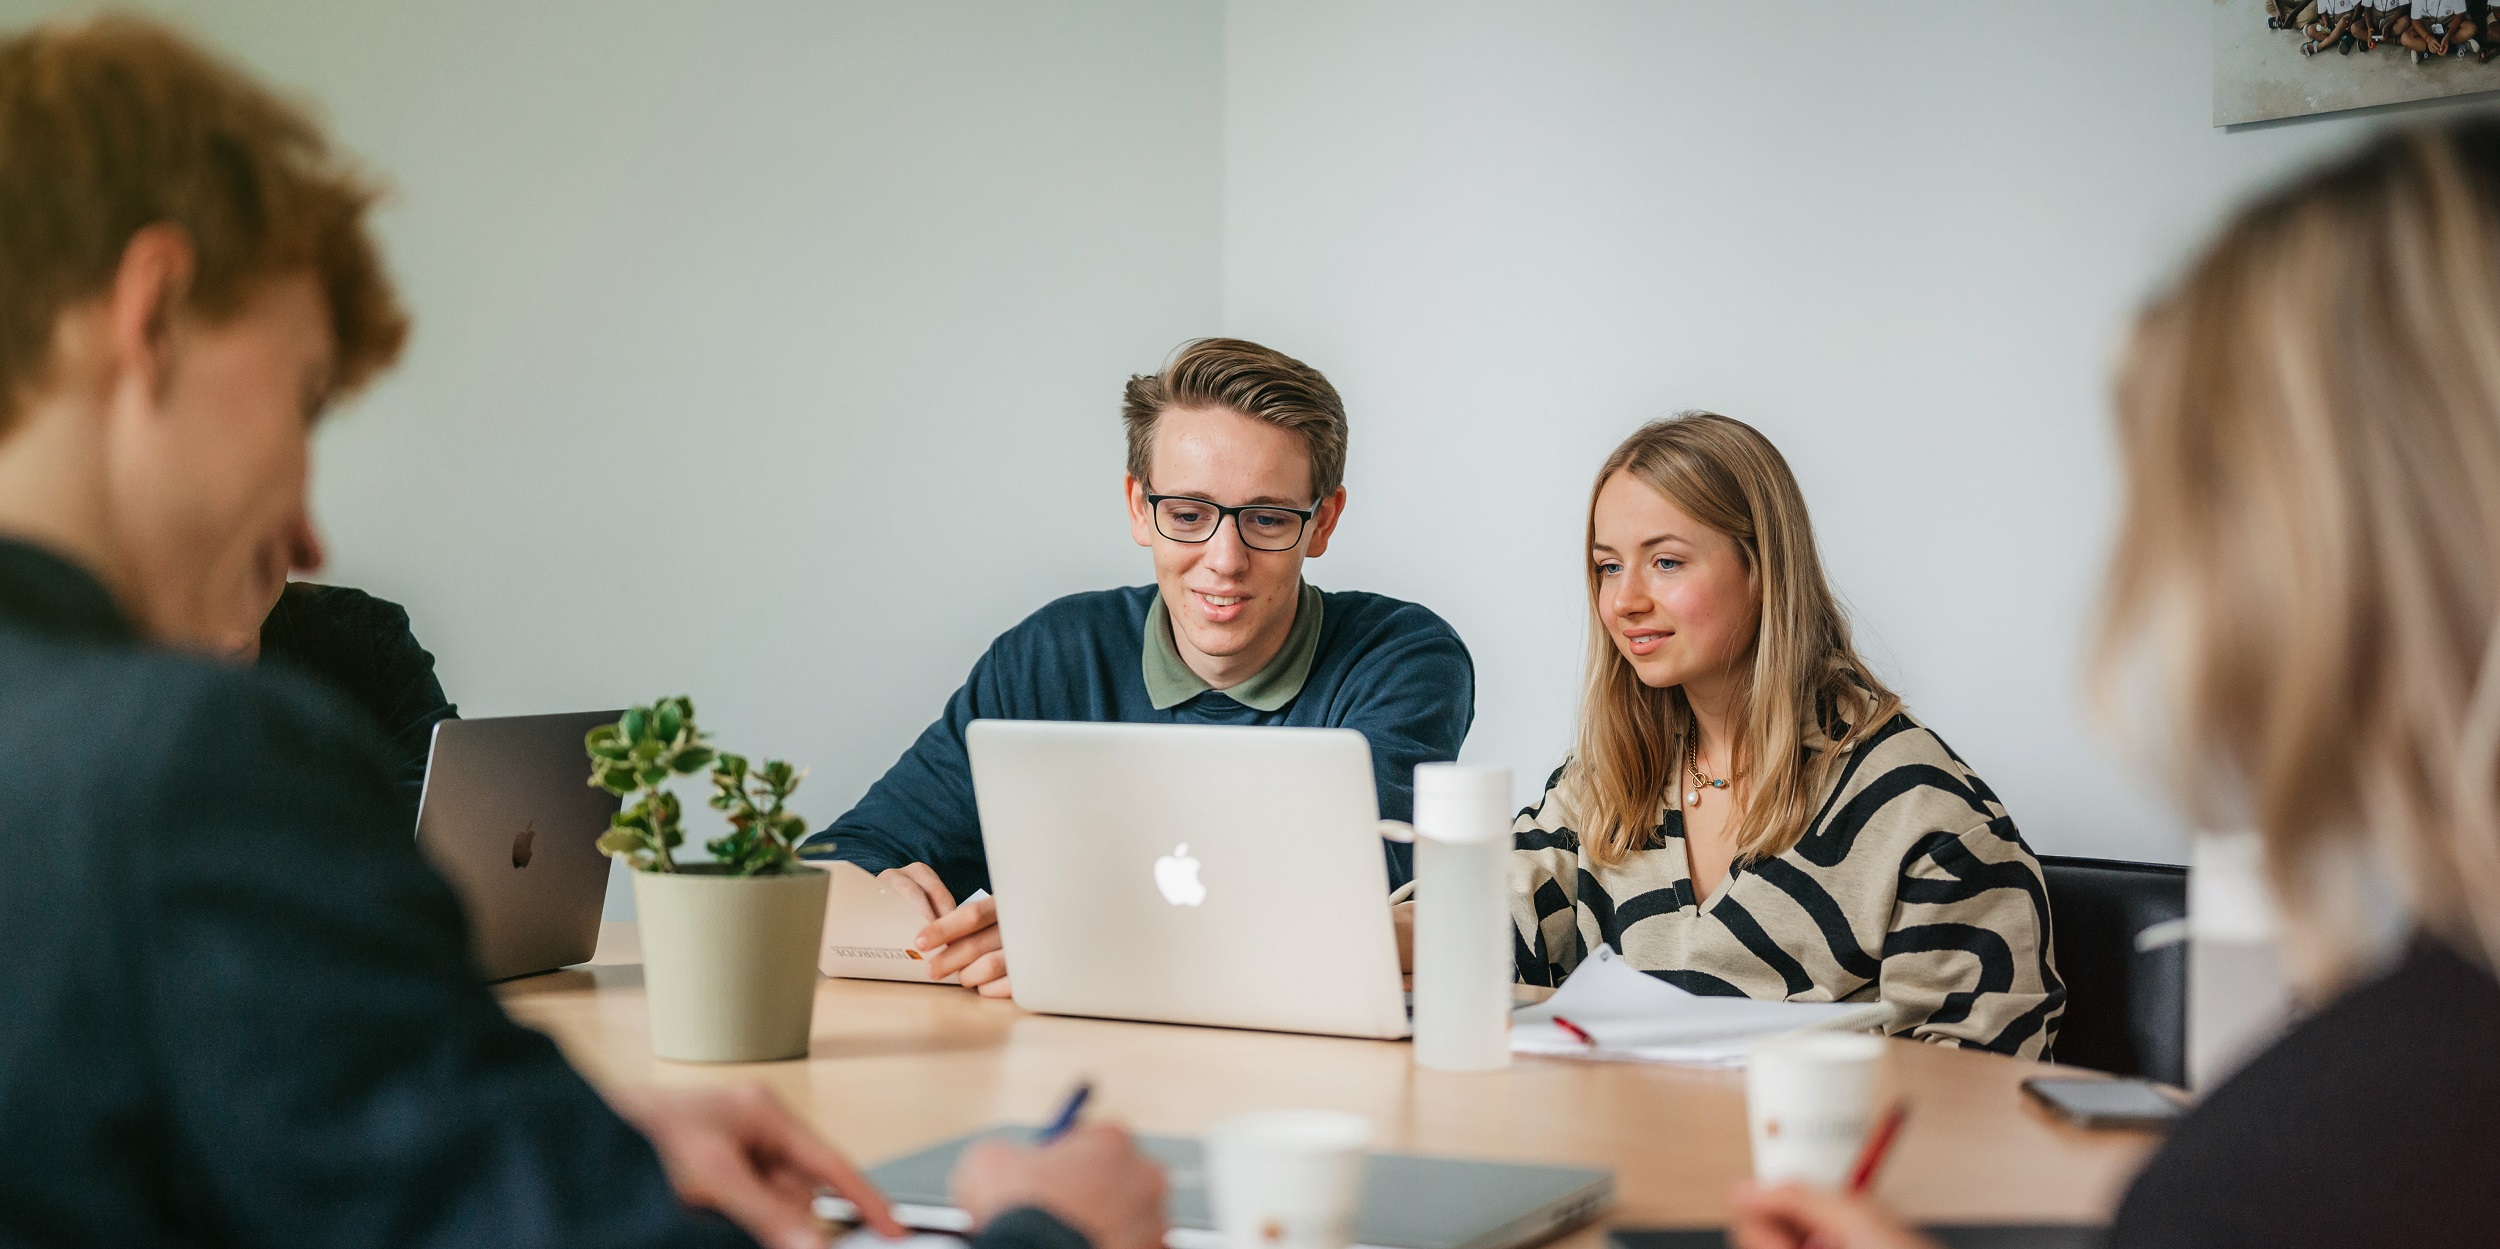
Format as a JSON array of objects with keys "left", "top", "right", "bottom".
[{"left": 2040, "top": 854, "right": 2188, "bottom": 1084}]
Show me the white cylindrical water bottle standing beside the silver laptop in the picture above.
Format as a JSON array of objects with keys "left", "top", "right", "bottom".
[{"left": 1415, "top": 764, "right": 1513, "bottom": 1072}]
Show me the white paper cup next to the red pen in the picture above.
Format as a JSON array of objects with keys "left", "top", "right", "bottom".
[{"left": 1745, "top": 1032, "right": 1883, "bottom": 1189}]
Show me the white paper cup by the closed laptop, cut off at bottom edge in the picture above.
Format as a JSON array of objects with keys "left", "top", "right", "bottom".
[{"left": 1208, "top": 1109, "right": 1373, "bottom": 1249}]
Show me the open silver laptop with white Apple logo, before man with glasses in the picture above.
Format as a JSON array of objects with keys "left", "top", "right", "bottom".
[{"left": 965, "top": 719, "right": 1408, "bottom": 1037}]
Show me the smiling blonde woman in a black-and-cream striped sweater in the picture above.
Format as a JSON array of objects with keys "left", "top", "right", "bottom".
[{"left": 1513, "top": 412, "right": 2065, "bottom": 1057}]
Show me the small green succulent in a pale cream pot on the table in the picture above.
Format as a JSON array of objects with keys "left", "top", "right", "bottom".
[{"left": 583, "top": 697, "right": 828, "bottom": 1062}]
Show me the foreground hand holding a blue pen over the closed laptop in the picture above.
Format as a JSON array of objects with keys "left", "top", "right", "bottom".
[{"left": 953, "top": 1124, "right": 1163, "bottom": 1249}]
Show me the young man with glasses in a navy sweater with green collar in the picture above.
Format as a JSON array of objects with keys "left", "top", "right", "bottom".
[{"left": 810, "top": 337, "right": 1475, "bottom": 997}]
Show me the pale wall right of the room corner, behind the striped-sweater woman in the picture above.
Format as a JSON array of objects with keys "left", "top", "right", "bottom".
[{"left": 1225, "top": 0, "right": 2440, "bottom": 859}]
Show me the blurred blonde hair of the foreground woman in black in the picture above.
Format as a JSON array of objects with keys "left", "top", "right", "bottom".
[{"left": 2100, "top": 122, "right": 2500, "bottom": 987}]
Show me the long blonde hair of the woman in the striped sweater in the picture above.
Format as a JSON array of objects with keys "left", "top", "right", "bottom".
[{"left": 1573, "top": 412, "right": 1900, "bottom": 867}]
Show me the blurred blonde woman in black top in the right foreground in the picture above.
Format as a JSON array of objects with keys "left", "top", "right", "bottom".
[{"left": 1735, "top": 122, "right": 2500, "bottom": 1249}]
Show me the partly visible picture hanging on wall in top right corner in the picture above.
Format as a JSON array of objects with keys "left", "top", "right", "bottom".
[{"left": 2213, "top": 0, "right": 2500, "bottom": 125}]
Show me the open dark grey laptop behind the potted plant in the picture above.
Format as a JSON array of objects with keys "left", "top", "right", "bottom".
[{"left": 418, "top": 712, "right": 625, "bottom": 979}]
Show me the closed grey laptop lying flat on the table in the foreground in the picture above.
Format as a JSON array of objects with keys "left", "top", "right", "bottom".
[{"left": 818, "top": 1129, "right": 1615, "bottom": 1249}]
